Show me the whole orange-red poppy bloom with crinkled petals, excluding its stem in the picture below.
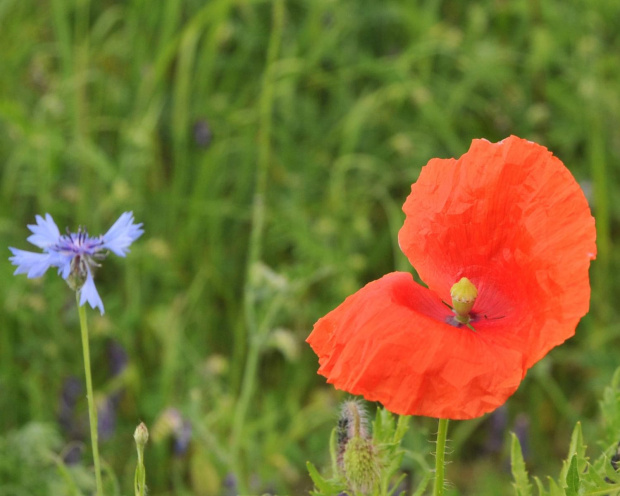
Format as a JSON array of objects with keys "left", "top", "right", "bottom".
[{"left": 307, "top": 136, "right": 596, "bottom": 419}]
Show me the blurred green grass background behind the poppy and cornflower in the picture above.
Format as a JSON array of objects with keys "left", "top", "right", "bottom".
[{"left": 0, "top": 0, "right": 620, "bottom": 495}]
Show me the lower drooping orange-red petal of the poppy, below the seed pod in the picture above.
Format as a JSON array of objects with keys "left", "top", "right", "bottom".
[{"left": 307, "top": 272, "right": 526, "bottom": 419}]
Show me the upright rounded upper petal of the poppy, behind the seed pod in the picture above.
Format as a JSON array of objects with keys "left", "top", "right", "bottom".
[{"left": 399, "top": 136, "right": 596, "bottom": 368}]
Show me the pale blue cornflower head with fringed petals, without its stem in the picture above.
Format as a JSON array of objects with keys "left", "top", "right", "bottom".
[{"left": 9, "top": 212, "right": 144, "bottom": 315}]
